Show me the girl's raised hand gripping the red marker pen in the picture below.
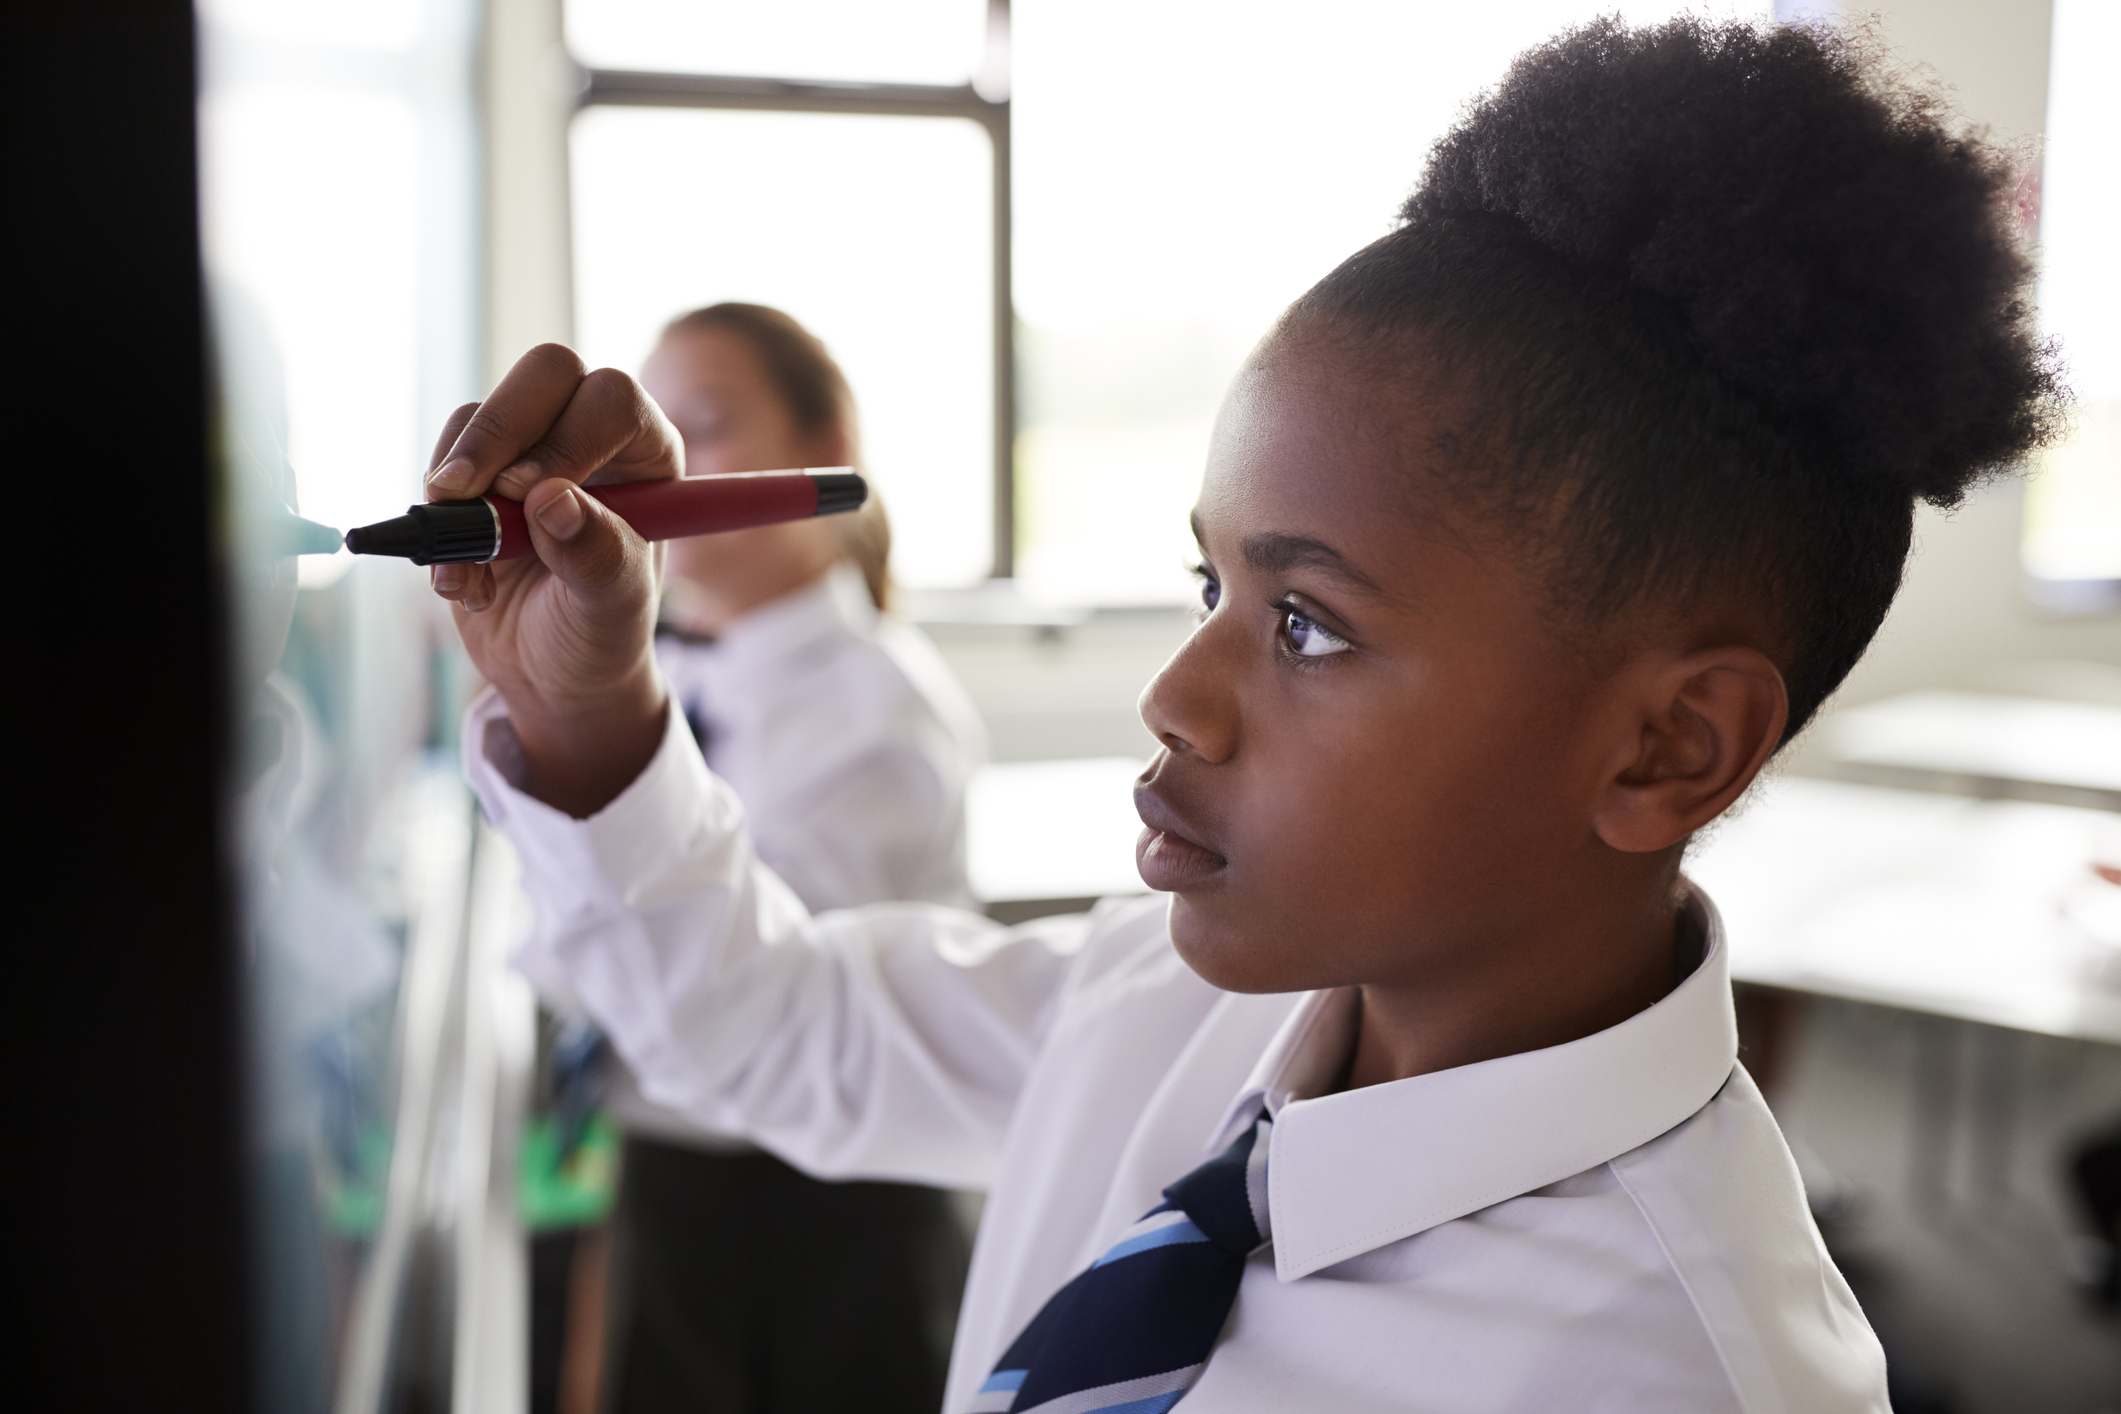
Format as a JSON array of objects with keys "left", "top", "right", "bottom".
[{"left": 426, "top": 343, "right": 685, "bottom": 816}]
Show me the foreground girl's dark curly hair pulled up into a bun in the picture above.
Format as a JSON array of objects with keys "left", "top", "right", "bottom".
[{"left": 1283, "top": 19, "right": 2064, "bottom": 740}]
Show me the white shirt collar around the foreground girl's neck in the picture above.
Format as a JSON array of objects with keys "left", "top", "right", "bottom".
[{"left": 1209, "top": 884, "right": 1737, "bottom": 1280}]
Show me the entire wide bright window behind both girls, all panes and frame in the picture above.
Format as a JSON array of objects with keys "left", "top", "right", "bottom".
[{"left": 566, "top": 0, "right": 1763, "bottom": 604}]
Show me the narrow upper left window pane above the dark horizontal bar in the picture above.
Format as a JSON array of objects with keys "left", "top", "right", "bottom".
[{"left": 566, "top": 0, "right": 986, "bottom": 83}]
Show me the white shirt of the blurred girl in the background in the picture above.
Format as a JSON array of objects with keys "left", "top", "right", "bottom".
[{"left": 606, "top": 562, "right": 986, "bottom": 1149}]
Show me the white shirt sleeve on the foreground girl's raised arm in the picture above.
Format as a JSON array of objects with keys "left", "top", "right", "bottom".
[{"left": 464, "top": 691, "right": 1088, "bottom": 1187}]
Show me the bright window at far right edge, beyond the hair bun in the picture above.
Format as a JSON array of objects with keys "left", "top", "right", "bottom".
[{"left": 2026, "top": 0, "right": 2121, "bottom": 608}]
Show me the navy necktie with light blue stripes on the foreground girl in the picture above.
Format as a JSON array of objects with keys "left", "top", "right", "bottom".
[{"left": 965, "top": 1117, "right": 1273, "bottom": 1414}]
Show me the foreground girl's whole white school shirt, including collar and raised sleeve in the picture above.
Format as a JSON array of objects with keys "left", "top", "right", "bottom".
[{"left": 481, "top": 695, "right": 1888, "bottom": 1414}]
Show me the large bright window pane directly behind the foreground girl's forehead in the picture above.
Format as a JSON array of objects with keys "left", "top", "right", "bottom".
[{"left": 1012, "top": 0, "right": 1765, "bottom": 602}]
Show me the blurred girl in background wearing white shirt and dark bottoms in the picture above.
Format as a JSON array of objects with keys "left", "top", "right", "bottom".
[{"left": 545, "top": 303, "right": 984, "bottom": 1414}]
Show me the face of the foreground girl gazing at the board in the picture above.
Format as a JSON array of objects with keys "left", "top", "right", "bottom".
[{"left": 1137, "top": 348, "right": 1614, "bottom": 992}]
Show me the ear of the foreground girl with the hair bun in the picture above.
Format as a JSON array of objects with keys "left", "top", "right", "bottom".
[{"left": 1591, "top": 649, "right": 1790, "bottom": 854}]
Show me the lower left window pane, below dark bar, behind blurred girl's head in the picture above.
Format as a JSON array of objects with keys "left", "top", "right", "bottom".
[{"left": 573, "top": 108, "right": 993, "bottom": 585}]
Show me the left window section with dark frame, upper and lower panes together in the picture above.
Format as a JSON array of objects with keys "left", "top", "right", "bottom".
[{"left": 566, "top": 0, "right": 1014, "bottom": 587}]
